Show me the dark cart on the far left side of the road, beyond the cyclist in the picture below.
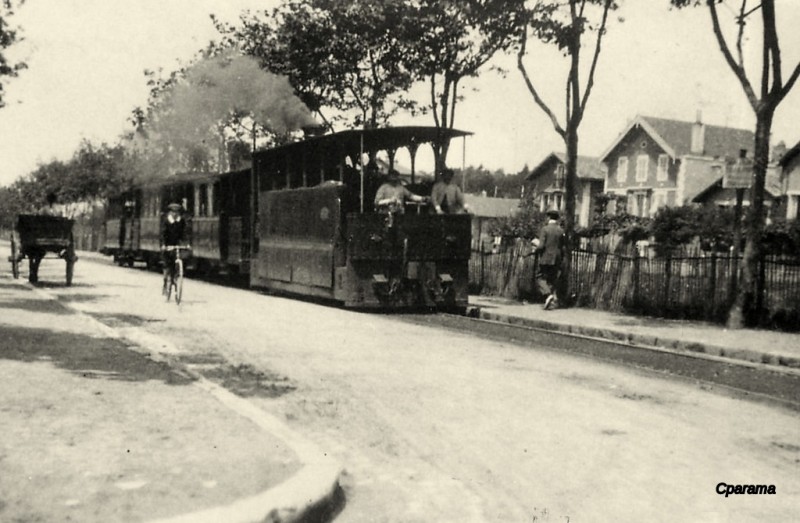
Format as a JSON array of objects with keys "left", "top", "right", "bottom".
[{"left": 9, "top": 214, "right": 78, "bottom": 285}]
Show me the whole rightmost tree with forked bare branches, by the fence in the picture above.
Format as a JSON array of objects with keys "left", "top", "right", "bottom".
[{"left": 670, "top": 0, "right": 800, "bottom": 328}]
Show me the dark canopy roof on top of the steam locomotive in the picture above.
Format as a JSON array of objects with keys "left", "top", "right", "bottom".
[{"left": 255, "top": 126, "right": 472, "bottom": 161}]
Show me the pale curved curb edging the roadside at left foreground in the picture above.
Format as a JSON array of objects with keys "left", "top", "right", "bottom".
[{"left": 22, "top": 282, "right": 343, "bottom": 523}]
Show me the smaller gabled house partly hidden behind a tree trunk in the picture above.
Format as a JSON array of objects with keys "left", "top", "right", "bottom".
[{"left": 526, "top": 152, "right": 606, "bottom": 227}]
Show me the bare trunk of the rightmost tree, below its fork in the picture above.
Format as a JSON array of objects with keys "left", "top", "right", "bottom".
[{"left": 728, "top": 107, "right": 774, "bottom": 329}]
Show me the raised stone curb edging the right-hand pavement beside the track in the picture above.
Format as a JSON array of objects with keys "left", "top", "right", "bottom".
[{"left": 467, "top": 306, "right": 800, "bottom": 372}]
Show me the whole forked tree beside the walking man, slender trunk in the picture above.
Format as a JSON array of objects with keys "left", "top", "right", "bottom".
[{"left": 517, "top": 0, "right": 617, "bottom": 308}]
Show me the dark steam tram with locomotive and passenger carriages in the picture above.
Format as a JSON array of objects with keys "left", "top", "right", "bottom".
[{"left": 103, "top": 127, "right": 471, "bottom": 309}]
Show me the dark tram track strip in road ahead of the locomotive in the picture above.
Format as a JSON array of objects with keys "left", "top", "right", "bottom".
[{"left": 400, "top": 314, "right": 800, "bottom": 411}]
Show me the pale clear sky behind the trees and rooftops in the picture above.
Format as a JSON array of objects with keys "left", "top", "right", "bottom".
[{"left": 0, "top": 0, "right": 800, "bottom": 185}]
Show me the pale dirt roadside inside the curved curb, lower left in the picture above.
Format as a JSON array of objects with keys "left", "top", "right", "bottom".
[{"left": 0, "top": 275, "right": 301, "bottom": 523}]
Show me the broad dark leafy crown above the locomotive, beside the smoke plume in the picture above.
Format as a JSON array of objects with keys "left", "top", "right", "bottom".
[{"left": 216, "top": 0, "right": 416, "bottom": 129}]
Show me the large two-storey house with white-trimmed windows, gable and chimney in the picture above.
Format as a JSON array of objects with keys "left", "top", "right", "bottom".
[{"left": 600, "top": 113, "right": 755, "bottom": 217}]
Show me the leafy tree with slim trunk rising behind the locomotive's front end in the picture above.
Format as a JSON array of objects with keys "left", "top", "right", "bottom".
[{"left": 410, "top": 0, "right": 525, "bottom": 170}]
